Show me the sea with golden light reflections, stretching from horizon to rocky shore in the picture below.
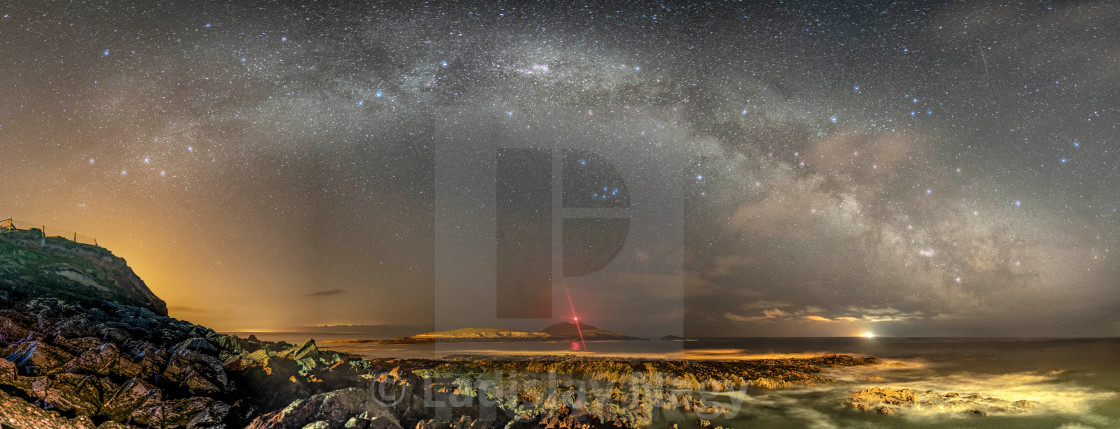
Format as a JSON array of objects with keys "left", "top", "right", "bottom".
[{"left": 229, "top": 334, "right": 1120, "bottom": 429}]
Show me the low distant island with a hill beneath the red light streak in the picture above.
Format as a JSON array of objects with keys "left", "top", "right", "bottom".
[{"left": 367, "top": 321, "right": 646, "bottom": 344}]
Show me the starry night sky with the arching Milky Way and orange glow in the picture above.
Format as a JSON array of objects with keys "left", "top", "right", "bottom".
[{"left": 0, "top": 1, "right": 1120, "bottom": 336}]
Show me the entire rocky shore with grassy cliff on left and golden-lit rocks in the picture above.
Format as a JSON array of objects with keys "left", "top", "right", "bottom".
[{"left": 0, "top": 231, "right": 878, "bottom": 429}]
